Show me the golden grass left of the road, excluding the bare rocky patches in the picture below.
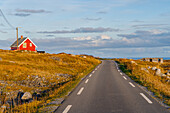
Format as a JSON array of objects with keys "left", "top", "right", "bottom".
[{"left": 0, "top": 50, "right": 101, "bottom": 113}]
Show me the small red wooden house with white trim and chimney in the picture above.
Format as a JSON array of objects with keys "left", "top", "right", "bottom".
[{"left": 10, "top": 36, "right": 37, "bottom": 51}]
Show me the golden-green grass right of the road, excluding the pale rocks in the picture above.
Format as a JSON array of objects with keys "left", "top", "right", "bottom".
[{"left": 115, "top": 59, "right": 170, "bottom": 106}]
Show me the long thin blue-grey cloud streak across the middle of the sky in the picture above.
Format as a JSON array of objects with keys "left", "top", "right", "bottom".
[{"left": 37, "top": 27, "right": 119, "bottom": 34}]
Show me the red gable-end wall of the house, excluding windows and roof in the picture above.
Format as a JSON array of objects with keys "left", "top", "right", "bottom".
[{"left": 19, "top": 39, "right": 36, "bottom": 51}]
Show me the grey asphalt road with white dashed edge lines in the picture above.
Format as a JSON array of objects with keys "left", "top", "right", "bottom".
[{"left": 55, "top": 60, "right": 170, "bottom": 113}]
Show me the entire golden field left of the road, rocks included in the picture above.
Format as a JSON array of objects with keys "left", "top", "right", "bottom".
[{"left": 0, "top": 50, "right": 101, "bottom": 113}]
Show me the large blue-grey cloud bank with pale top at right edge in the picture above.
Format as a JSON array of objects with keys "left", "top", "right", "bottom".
[{"left": 118, "top": 30, "right": 170, "bottom": 47}]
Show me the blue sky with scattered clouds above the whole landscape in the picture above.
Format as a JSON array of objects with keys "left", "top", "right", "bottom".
[{"left": 0, "top": 0, "right": 170, "bottom": 58}]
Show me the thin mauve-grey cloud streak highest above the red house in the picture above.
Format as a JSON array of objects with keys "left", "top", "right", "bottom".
[{"left": 16, "top": 9, "right": 51, "bottom": 13}]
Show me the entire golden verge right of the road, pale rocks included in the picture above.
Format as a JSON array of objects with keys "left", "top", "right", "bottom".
[{"left": 115, "top": 59, "right": 170, "bottom": 106}]
